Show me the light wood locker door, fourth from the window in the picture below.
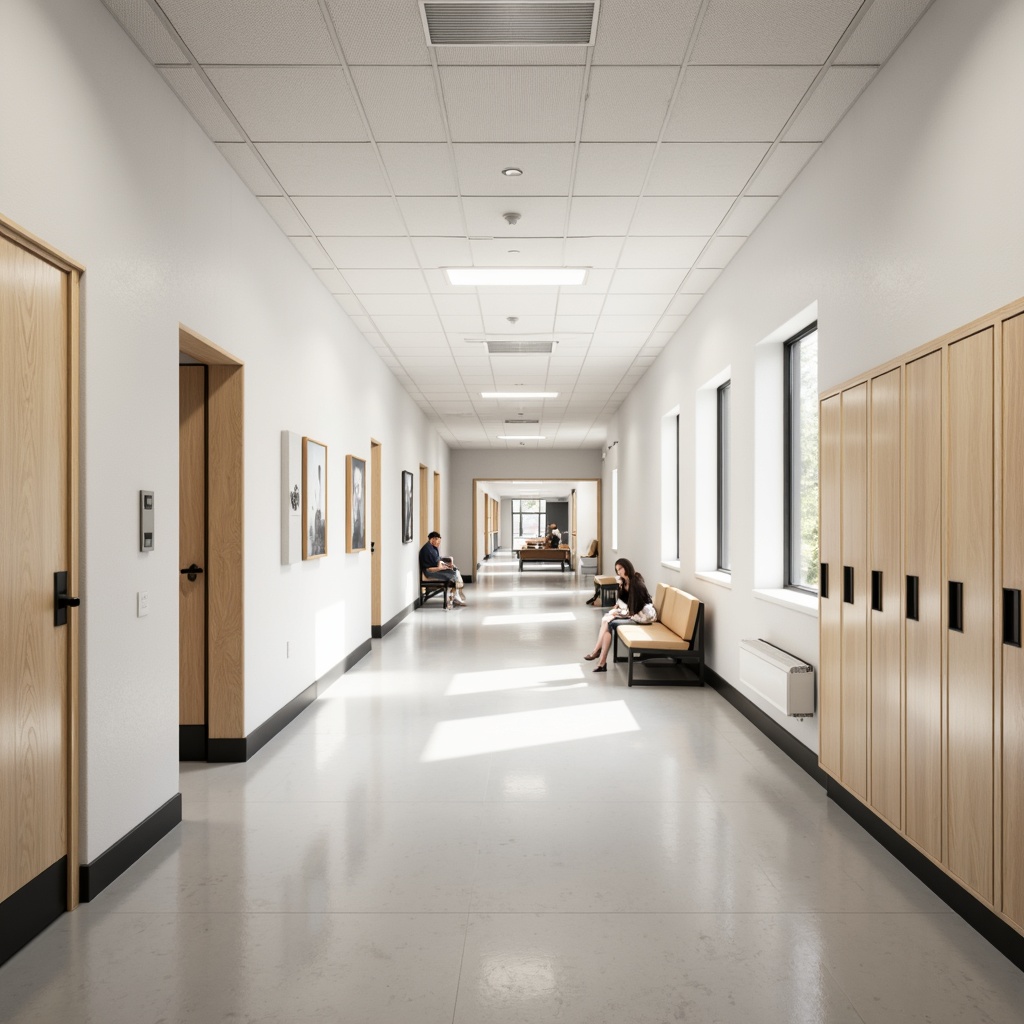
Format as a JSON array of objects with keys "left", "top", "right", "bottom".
[{"left": 903, "top": 351, "right": 945, "bottom": 860}]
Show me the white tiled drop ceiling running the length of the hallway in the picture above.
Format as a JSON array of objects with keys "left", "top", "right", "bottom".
[{"left": 103, "top": 0, "right": 931, "bottom": 449}]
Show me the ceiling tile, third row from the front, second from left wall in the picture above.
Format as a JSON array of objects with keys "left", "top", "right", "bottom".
[{"left": 256, "top": 142, "right": 388, "bottom": 196}]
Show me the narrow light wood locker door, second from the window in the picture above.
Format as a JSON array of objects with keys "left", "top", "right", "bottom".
[{"left": 841, "top": 382, "right": 869, "bottom": 799}]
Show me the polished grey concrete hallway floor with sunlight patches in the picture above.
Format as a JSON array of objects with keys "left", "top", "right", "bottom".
[{"left": 0, "top": 557, "right": 1024, "bottom": 1024}]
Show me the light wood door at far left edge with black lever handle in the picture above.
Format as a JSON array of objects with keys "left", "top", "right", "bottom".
[{"left": 0, "top": 234, "right": 78, "bottom": 903}]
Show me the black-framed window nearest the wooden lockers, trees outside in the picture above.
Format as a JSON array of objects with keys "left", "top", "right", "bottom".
[{"left": 783, "top": 323, "right": 818, "bottom": 593}]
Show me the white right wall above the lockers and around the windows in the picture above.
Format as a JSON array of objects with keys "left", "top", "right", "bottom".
[{"left": 604, "top": 0, "right": 1024, "bottom": 750}]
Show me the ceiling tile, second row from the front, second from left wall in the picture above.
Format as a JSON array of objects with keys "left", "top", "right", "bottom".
[{"left": 204, "top": 68, "right": 367, "bottom": 142}]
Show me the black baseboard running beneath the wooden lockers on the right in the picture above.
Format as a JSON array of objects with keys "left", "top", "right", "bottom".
[{"left": 825, "top": 776, "right": 1024, "bottom": 971}]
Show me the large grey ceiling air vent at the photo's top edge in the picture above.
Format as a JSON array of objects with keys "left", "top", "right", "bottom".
[{"left": 420, "top": 0, "right": 599, "bottom": 46}]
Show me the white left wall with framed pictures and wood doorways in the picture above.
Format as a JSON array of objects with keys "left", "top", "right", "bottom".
[{"left": 0, "top": 0, "right": 449, "bottom": 861}]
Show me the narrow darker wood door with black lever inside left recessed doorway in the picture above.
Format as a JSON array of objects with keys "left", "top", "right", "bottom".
[{"left": 178, "top": 366, "right": 207, "bottom": 725}]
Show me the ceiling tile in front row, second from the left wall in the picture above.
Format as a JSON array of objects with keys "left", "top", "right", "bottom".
[{"left": 160, "top": 0, "right": 338, "bottom": 65}]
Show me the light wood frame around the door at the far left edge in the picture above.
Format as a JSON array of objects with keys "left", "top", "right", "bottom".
[{"left": 0, "top": 214, "right": 85, "bottom": 910}]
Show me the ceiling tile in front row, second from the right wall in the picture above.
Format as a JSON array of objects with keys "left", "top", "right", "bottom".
[{"left": 691, "top": 0, "right": 861, "bottom": 65}]
